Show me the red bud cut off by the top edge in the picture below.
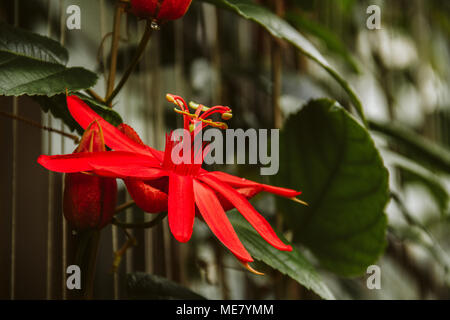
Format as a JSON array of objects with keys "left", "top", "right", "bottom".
[{"left": 131, "top": 0, "right": 192, "bottom": 20}]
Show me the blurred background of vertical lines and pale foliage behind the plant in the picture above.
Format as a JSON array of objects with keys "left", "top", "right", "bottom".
[{"left": 0, "top": 0, "right": 450, "bottom": 299}]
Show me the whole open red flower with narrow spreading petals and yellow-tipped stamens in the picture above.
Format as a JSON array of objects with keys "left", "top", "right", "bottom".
[{"left": 38, "top": 95, "right": 306, "bottom": 270}]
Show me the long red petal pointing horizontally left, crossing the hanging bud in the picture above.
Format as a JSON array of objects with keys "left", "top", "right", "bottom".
[{"left": 37, "top": 151, "right": 159, "bottom": 172}]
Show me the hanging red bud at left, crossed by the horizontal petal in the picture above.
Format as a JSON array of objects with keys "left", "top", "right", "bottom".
[{"left": 63, "top": 122, "right": 117, "bottom": 230}]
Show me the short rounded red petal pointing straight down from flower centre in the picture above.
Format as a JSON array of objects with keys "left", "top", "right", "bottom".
[{"left": 167, "top": 173, "right": 195, "bottom": 242}]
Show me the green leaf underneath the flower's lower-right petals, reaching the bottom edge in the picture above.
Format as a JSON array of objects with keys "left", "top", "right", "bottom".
[{"left": 228, "top": 211, "right": 334, "bottom": 299}]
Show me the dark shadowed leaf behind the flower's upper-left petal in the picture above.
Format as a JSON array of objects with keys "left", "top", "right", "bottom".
[{"left": 33, "top": 93, "right": 123, "bottom": 135}]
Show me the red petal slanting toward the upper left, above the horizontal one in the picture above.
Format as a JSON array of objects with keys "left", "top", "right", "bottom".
[{"left": 67, "top": 96, "right": 162, "bottom": 161}]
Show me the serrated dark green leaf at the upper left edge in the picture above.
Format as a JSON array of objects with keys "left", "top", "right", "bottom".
[{"left": 0, "top": 23, "right": 97, "bottom": 96}]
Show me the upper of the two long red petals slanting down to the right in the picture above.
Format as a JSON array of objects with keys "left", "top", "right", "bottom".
[{"left": 200, "top": 175, "right": 292, "bottom": 251}]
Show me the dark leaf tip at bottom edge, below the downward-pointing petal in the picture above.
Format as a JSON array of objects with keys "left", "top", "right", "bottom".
[{"left": 127, "top": 272, "right": 205, "bottom": 300}]
